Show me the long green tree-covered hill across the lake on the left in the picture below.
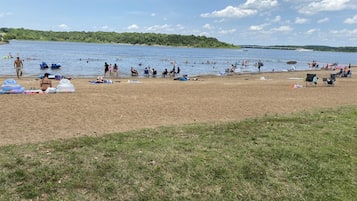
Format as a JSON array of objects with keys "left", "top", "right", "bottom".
[{"left": 0, "top": 28, "right": 239, "bottom": 48}]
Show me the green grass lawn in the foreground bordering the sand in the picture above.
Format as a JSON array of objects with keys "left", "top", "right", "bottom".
[{"left": 0, "top": 106, "right": 357, "bottom": 201}]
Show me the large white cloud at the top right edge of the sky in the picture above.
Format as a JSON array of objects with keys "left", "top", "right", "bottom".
[{"left": 299, "top": 0, "right": 350, "bottom": 15}]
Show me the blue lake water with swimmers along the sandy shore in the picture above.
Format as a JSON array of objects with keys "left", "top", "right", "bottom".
[{"left": 0, "top": 40, "right": 357, "bottom": 78}]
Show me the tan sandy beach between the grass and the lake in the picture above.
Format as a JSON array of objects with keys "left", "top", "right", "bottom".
[{"left": 0, "top": 68, "right": 357, "bottom": 146}]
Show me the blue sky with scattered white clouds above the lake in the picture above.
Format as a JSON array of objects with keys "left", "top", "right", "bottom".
[{"left": 0, "top": 0, "right": 357, "bottom": 46}]
